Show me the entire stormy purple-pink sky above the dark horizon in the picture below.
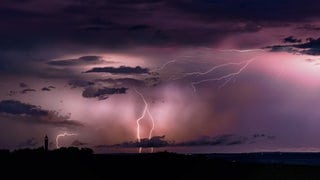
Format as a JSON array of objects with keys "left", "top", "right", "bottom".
[{"left": 0, "top": 0, "right": 320, "bottom": 152}]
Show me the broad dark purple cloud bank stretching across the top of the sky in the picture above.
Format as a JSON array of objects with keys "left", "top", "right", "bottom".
[{"left": 0, "top": 0, "right": 296, "bottom": 52}]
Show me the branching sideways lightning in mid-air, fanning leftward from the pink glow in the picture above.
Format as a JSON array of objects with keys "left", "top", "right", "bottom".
[{"left": 191, "top": 58, "right": 255, "bottom": 92}]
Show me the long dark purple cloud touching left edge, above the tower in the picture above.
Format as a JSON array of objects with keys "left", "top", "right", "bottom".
[{"left": 0, "top": 100, "right": 83, "bottom": 127}]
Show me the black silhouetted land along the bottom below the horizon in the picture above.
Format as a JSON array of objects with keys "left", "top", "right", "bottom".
[{"left": 0, "top": 148, "right": 320, "bottom": 180}]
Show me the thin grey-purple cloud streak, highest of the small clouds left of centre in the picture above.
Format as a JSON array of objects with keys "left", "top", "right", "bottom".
[{"left": 47, "top": 56, "right": 106, "bottom": 66}]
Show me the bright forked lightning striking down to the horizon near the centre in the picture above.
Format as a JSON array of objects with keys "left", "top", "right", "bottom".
[{"left": 135, "top": 89, "right": 155, "bottom": 142}]
